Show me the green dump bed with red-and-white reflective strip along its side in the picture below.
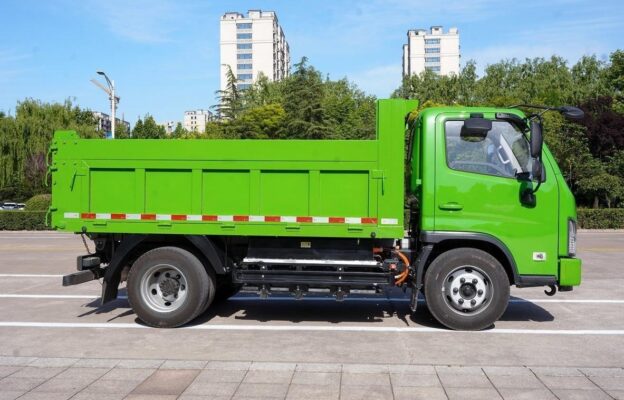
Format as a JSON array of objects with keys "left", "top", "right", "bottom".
[{"left": 49, "top": 100, "right": 416, "bottom": 238}]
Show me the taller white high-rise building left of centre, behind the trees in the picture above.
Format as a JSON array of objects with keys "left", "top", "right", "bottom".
[{"left": 221, "top": 10, "right": 290, "bottom": 90}]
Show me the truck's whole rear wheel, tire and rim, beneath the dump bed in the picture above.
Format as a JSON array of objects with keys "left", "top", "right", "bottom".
[{"left": 128, "top": 247, "right": 215, "bottom": 328}]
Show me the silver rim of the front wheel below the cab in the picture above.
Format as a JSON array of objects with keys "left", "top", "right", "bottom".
[{"left": 442, "top": 265, "right": 494, "bottom": 315}]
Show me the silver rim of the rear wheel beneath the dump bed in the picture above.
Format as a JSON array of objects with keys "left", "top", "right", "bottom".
[{"left": 141, "top": 264, "right": 188, "bottom": 313}]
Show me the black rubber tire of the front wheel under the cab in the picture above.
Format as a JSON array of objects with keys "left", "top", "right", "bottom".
[{"left": 425, "top": 247, "right": 509, "bottom": 331}]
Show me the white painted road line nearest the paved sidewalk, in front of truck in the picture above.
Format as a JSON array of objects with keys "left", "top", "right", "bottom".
[{"left": 0, "top": 321, "right": 624, "bottom": 336}]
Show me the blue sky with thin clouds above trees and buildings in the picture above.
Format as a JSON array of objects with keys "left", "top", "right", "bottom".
[{"left": 0, "top": 0, "right": 624, "bottom": 124}]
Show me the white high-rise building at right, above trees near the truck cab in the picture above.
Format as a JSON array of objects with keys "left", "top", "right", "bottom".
[{"left": 403, "top": 26, "right": 461, "bottom": 76}]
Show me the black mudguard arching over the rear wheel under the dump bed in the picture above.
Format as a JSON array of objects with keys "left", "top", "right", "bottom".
[{"left": 102, "top": 235, "right": 230, "bottom": 304}]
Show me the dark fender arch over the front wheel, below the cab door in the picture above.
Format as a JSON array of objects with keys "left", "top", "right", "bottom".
[{"left": 416, "top": 231, "right": 519, "bottom": 288}]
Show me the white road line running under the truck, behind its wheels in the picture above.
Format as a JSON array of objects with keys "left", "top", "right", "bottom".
[{"left": 0, "top": 292, "right": 624, "bottom": 304}]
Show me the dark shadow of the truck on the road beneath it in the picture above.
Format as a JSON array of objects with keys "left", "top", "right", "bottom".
[{"left": 78, "top": 290, "right": 554, "bottom": 328}]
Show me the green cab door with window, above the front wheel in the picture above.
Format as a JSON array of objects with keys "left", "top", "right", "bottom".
[{"left": 434, "top": 113, "right": 558, "bottom": 275}]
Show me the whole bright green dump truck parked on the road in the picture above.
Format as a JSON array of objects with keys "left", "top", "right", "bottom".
[{"left": 49, "top": 99, "right": 582, "bottom": 330}]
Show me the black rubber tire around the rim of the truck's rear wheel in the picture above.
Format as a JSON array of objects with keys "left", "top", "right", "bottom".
[{"left": 127, "top": 247, "right": 215, "bottom": 328}]
